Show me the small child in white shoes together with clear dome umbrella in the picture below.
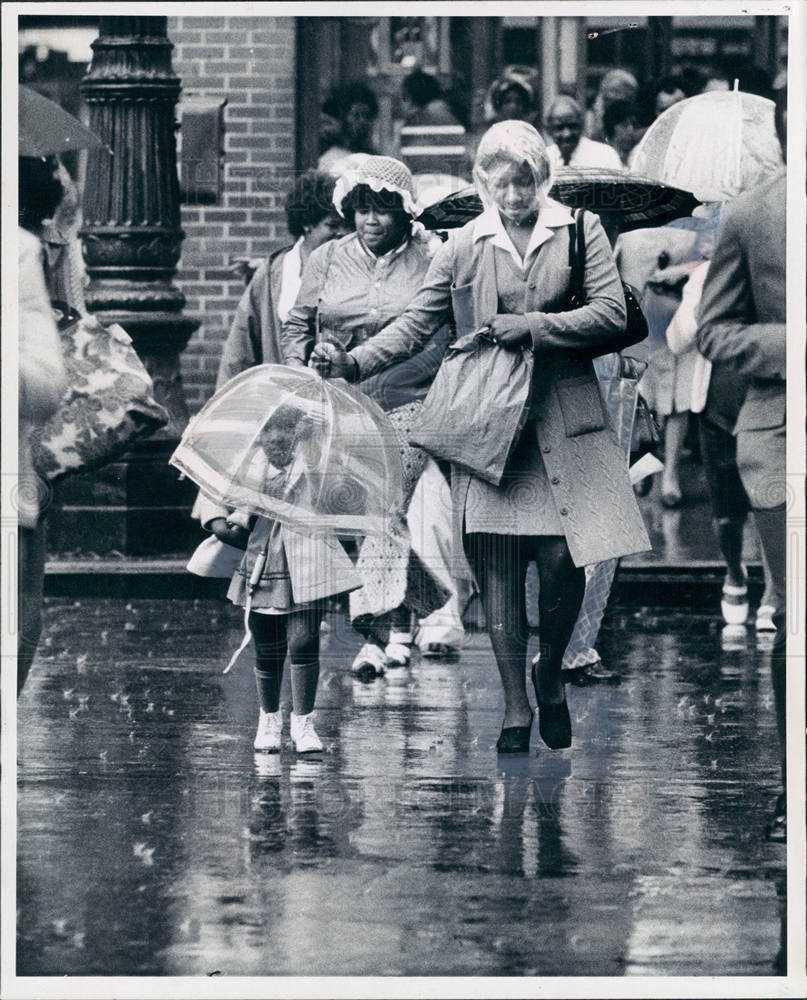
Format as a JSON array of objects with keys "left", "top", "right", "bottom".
[{"left": 172, "top": 365, "right": 408, "bottom": 753}]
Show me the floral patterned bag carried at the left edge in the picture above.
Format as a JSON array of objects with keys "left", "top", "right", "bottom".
[{"left": 31, "top": 312, "right": 168, "bottom": 482}]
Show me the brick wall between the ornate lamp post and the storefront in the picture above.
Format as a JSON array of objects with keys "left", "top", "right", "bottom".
[{"left": 168, "top": 17, "right": 295, "bottom": 412}]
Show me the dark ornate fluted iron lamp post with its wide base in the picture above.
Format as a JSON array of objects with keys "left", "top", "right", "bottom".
[{"left": 49, "top": 17, "right": 199, "bottom": 556}]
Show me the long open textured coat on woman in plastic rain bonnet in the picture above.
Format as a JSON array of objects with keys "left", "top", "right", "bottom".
[{"left": 350, "top": 213, "right": 650, "bottom": 566}]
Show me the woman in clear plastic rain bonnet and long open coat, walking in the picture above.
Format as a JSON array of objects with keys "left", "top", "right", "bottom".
[{"left": 315, "top": 121, "right": 650, "bottom": 753}]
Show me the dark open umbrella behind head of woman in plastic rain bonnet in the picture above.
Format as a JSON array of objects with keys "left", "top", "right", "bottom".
[{"left": 418, "top": 167, "right": 700, "bottom": 233}]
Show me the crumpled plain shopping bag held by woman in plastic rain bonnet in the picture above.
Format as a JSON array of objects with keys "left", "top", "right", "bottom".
[{"left": 409, "top": 330, "right": 534, "bottom": 486}]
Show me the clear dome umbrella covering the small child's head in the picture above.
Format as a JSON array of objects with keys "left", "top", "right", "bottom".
[{"left": 170, "top": 365, "right": 402, "bottom": 536}]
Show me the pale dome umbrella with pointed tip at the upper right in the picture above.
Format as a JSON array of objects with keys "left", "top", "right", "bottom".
[{"left": 633, "top": 90, "right": 783, "bottom": 201}]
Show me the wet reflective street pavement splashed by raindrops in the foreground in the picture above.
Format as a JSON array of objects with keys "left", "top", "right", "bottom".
[{"left": 17, "top": 598, "right": 785, "bottom": 976}]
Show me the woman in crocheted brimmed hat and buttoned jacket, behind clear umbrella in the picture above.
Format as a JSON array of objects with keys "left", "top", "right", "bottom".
[{"left": 282, "top": 156, "right": 449, "bottom": 676}]
